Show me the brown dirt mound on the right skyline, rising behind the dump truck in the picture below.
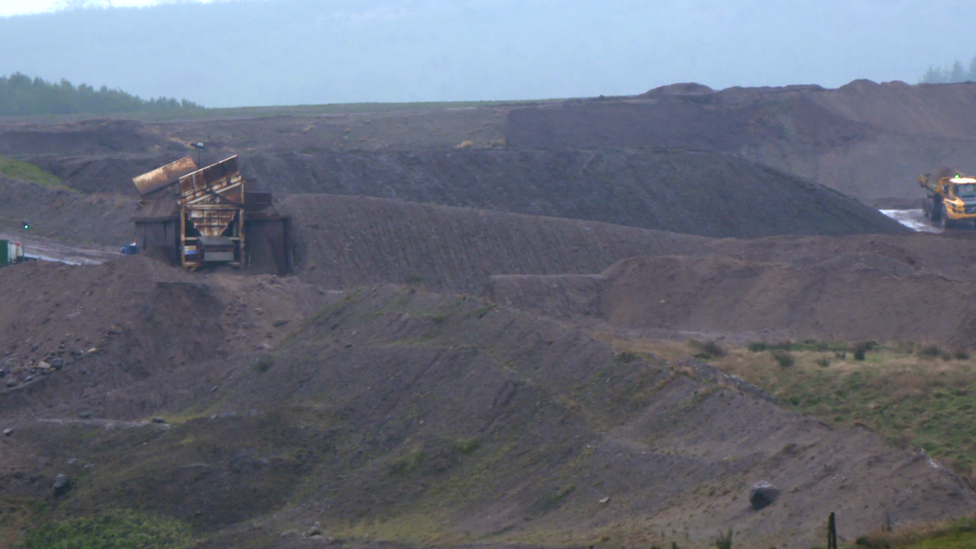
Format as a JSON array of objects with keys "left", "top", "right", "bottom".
[{"left": 505, "top": 81, "right": 976, "bottom": 206}]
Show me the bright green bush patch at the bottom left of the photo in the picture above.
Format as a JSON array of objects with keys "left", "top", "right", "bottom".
[{"left": 18, "top": 511, "right": 193, "bottom": 549}]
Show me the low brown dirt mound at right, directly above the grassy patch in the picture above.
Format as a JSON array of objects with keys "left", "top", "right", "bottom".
[{"left": 487, "top": 231, "right": 976, "bottom": 348}]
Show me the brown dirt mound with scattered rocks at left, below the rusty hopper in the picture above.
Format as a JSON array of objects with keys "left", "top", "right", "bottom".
[{"left": 0, "top": 256, "right": 336, "bottom": 417}]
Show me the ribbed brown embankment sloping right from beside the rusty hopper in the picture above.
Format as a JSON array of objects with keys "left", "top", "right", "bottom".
[{"left": 278, "top": 195, "right": 710, "bottom": 293}]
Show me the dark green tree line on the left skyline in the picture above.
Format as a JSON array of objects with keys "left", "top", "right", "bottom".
[{"left": 0, "top": 72, "right": 203, "bottom": 116}]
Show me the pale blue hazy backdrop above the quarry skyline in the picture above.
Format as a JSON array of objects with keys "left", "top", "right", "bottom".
[{"left": 0, "top": 0, "right": 976, "bottom": 107}]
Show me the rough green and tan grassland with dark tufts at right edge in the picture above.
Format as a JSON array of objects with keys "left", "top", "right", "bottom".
[{"left": 716, "top": 345, "right": 976, "bottom": 479}]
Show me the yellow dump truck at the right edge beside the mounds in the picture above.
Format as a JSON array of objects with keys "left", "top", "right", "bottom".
[{"left": 918, "top": 168, "right": 976, "bottom": 229}]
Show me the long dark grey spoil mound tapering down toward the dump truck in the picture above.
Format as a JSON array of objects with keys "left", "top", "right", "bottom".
[{"left": 255, "top": 150, "right": 906, "bottom": 238}]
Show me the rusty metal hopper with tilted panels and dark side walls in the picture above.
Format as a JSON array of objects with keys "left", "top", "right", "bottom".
[{"left": 132, "top": 155, "right": 292, "bottom": 274}]
